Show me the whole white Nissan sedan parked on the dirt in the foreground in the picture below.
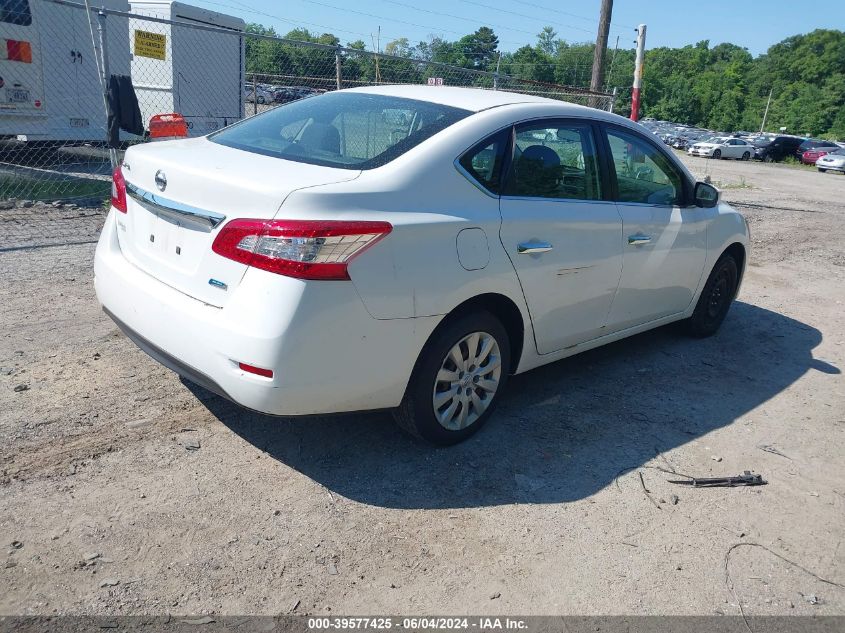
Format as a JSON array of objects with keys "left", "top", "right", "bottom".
[{"left": 95, "top": 86, "right": 748, "bottom": 444}]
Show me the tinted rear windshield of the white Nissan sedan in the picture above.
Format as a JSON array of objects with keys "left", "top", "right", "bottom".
[{"left": 209, "top": 92, "right": 471, "bottom": 169}]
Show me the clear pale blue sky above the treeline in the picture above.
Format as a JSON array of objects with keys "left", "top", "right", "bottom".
[{"left": 191, "top": 0, "right": 845, "bottom": 56}]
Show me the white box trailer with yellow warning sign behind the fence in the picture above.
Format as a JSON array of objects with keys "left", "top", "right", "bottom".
[{"left": 129, "top": 0, "right": 246, "bottom": 136}]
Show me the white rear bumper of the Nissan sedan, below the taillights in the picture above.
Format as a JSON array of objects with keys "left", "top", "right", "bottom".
[{"left": 94, "top": 211, "right": 440, "bottom": 415}]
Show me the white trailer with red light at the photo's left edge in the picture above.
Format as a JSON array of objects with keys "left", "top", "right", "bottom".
[{"left": 0, "top": 0, "right": 130, "bottom": 142}]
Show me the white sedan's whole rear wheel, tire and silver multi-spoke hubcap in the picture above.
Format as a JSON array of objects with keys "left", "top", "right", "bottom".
[{"left": 394, "top": 312, "right": 510, "bottom": 446}]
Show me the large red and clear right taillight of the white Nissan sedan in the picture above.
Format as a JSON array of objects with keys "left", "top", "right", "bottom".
[{"left": 211, "top": 220, "right": 393, "bottom": 280}]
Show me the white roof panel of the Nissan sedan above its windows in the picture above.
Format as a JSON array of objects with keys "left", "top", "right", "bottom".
[{"left": 343, "top": 85, "right": 576, "bottom": 112}]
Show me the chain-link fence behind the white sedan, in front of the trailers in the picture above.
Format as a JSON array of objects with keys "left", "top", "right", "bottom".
[{"left": 0, "top": 0, "right": 613, "bottom": 215}]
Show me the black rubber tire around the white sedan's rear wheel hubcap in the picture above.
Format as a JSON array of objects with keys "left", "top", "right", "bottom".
[{"left": 393, "top": 311, "right": 511, "bottom": 446}]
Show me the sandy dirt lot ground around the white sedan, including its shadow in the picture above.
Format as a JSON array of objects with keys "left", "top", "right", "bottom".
[{"left": 0, "top": 152, "right": 845, "bottom": 615}]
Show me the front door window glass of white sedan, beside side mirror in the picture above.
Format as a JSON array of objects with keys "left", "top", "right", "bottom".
[{"left": 607, "top": 130, "right": 683, "bottom": 205}]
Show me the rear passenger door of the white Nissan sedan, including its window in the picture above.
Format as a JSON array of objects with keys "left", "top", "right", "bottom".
[{"left": 499, "top": 119, "right": 622, "bottom": 354}]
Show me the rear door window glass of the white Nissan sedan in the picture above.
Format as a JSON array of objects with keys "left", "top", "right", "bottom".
[{"left": 505, "top": 121, "right": 601, "bottom": 200}]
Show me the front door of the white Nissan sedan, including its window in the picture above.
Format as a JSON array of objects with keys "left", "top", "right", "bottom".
[{"left": 605, "top": 126, "right": 712, "bottom": 331}]
